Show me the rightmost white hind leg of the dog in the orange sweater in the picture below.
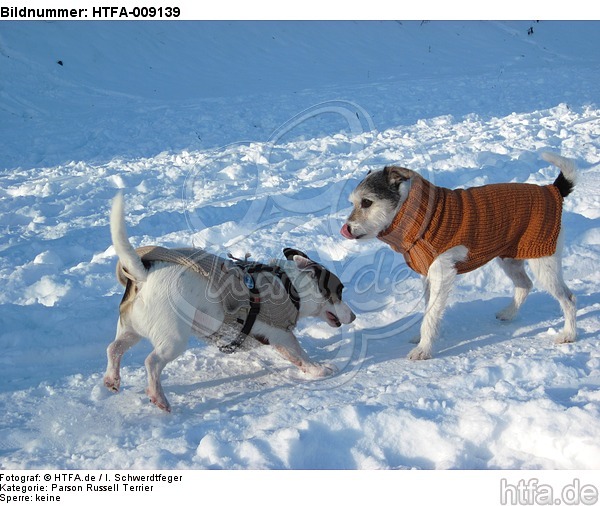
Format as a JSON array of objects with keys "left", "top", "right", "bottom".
[{"left": 529, "top": 253, "right": 577, "bottom": 344}]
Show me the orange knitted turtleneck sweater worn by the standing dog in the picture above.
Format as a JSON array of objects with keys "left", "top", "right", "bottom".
[{"left": 379, "top": 171, "right": 563, "bottom": 275}]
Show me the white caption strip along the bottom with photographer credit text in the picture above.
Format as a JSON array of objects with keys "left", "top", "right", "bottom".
[{"left": 0, "top": 470, "right": 600, "bottom": 506}]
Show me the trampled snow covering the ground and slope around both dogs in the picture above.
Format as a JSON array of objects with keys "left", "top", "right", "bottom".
[{"left": 0, "top": 21, "right": 600, "bottom": 469}]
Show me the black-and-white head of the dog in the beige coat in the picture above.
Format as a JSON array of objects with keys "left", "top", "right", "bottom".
[{"left": 283, "top": 248, "right": 356, "bottom": 327}]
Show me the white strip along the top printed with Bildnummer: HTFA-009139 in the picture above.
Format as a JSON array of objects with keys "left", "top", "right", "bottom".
[{"left": 2, "top": 0, "right": 600, "bottom": 21}]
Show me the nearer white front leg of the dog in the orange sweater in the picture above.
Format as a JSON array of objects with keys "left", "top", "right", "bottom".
[{"left": 408, "top": 246, "right": 468, "bottom": 360}]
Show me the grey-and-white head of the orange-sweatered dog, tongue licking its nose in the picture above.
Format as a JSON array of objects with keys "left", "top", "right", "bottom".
[{"left": 340, "top": 166, "right": 414, "bottom": 239}]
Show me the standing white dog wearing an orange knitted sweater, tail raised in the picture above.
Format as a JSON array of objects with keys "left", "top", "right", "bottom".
[{"left": 341, "top": 153, "right": 576, "bottom": 360}]
